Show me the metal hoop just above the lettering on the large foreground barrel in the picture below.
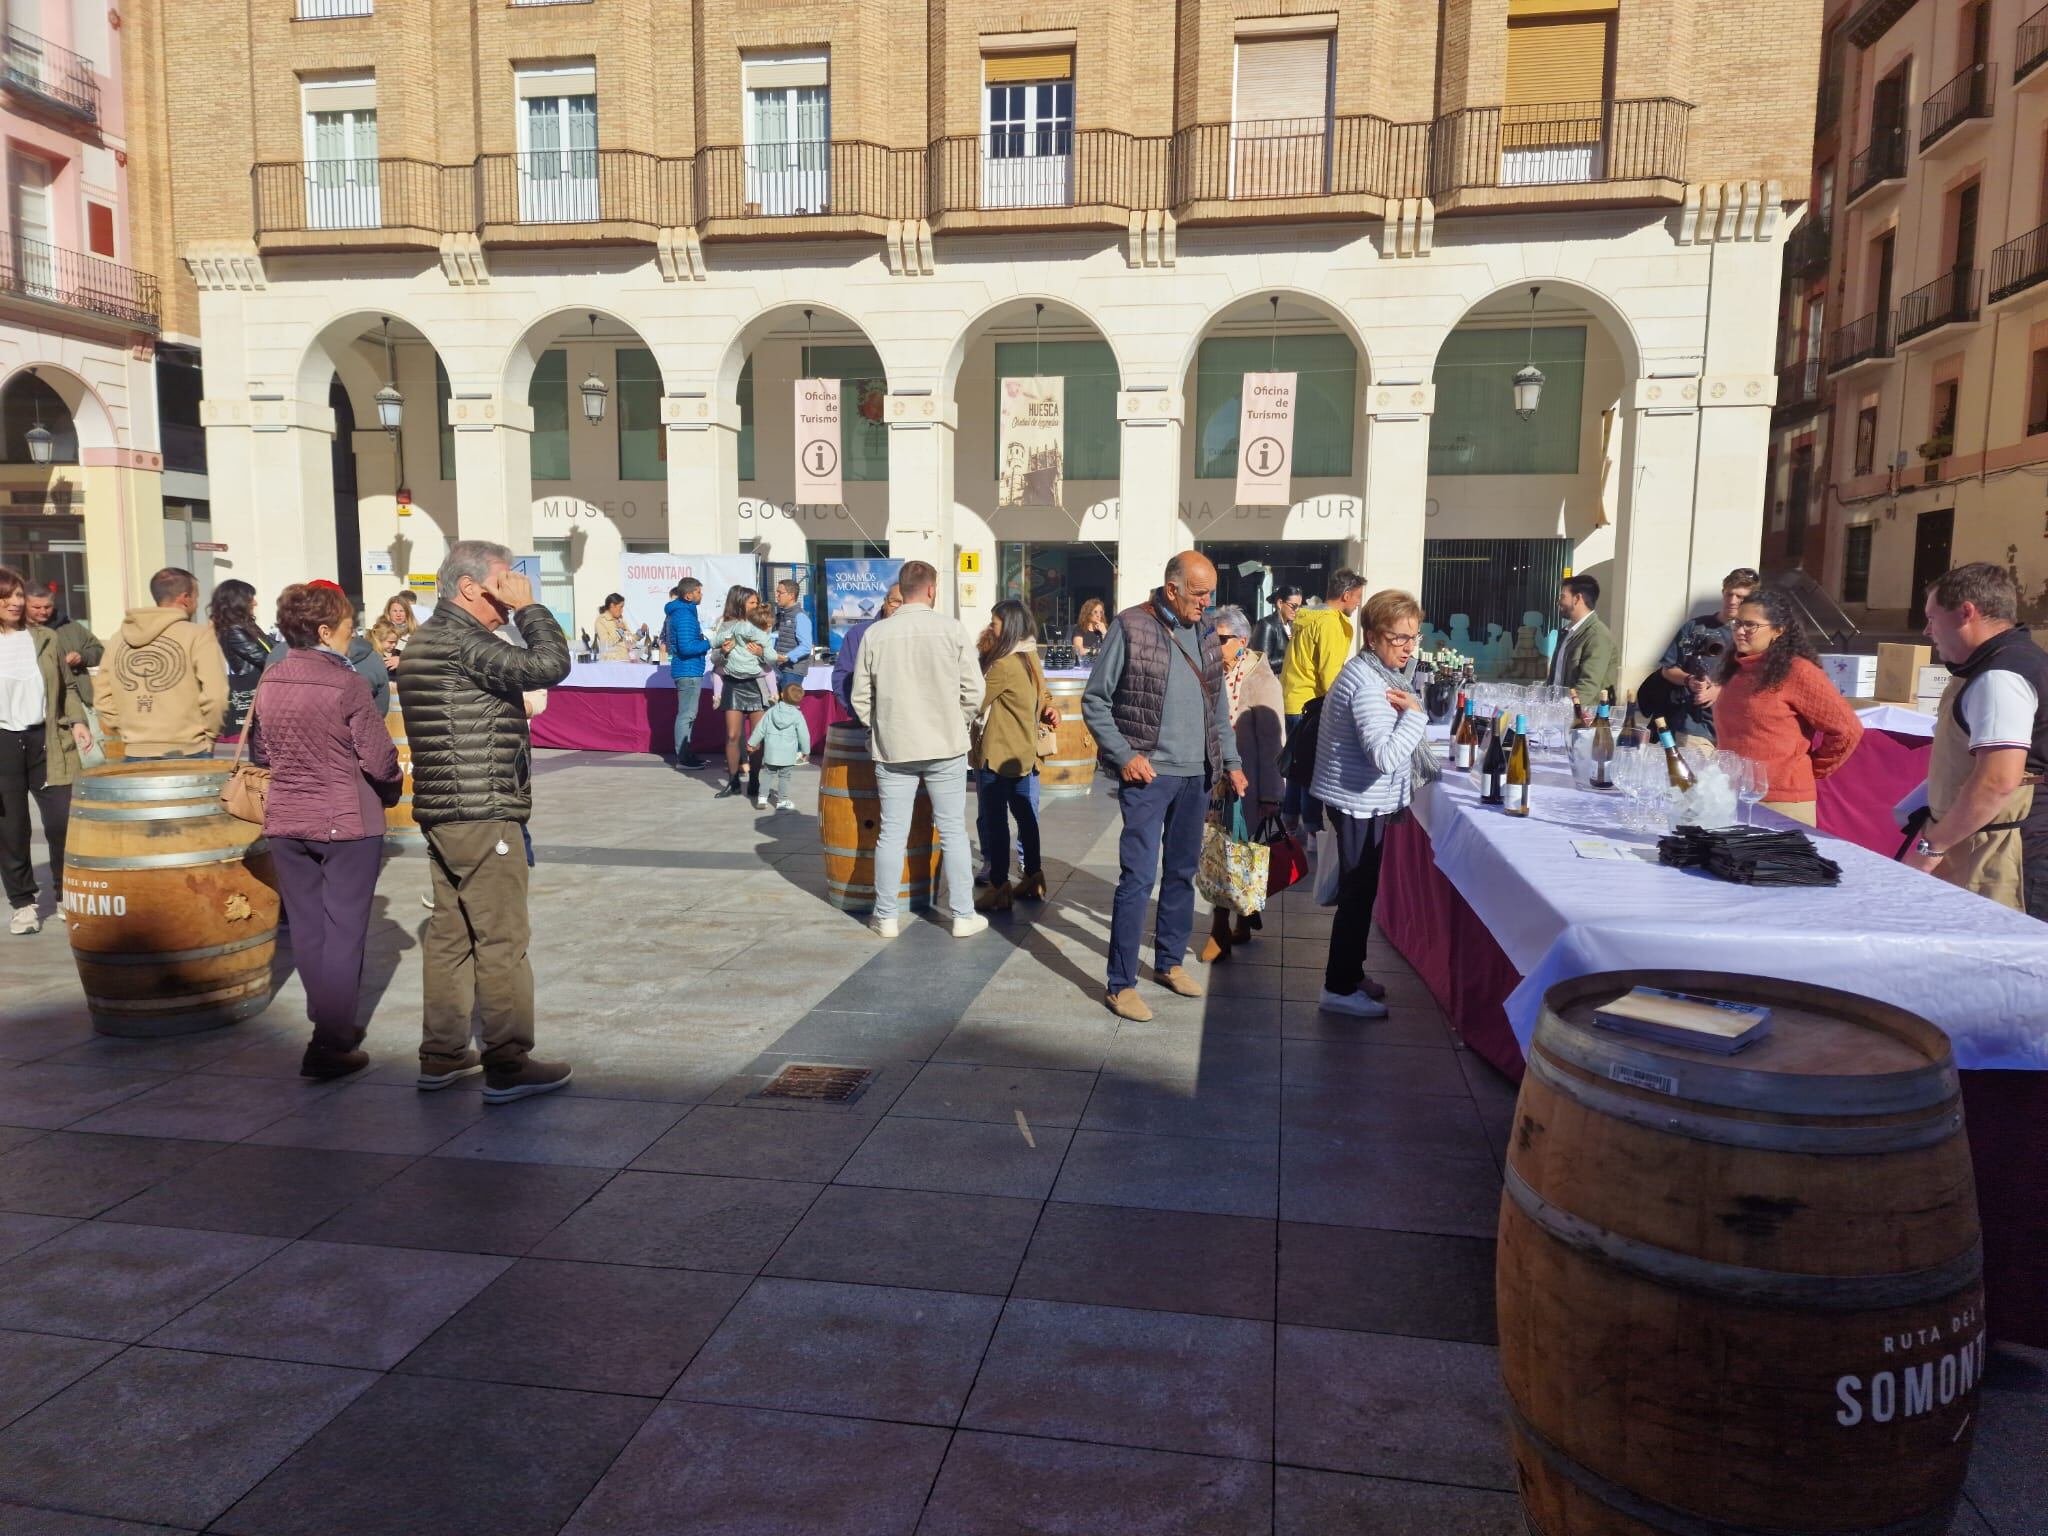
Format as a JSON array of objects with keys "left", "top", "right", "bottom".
[{"left": 1505, "top": 1163, "right": 1985, "bottom": 1313}]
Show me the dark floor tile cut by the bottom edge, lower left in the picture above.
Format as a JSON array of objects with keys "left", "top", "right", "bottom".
[{"left": 213, "top": 1376, "right": 651, "bottom": 1536}]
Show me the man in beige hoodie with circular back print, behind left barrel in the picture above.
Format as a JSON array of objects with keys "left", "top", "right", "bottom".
[{"left": 94, "top": 565, "right": 227, "bottom": 762}]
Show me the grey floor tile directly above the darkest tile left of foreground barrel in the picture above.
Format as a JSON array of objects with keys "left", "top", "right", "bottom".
[{"left": 1280, "top": 1130, "right": 1501, "bottom": 1237}]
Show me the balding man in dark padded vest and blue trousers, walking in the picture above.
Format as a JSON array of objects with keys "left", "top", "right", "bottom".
[{"left": 1081, "top": 549, "right": 1245, "bottom": 1020}]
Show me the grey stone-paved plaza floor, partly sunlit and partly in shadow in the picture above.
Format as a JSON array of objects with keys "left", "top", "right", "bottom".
[{"left": 0, "top": 754, "right": 2048, "bottom": 1536}]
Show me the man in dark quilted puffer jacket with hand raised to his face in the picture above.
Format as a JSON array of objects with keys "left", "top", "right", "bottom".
[{"left": 397, "top": 539, "right": 569, "bottom": 1104}]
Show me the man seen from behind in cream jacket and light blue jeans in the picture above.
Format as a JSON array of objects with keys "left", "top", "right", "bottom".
[{"left": 850, "top": 559, "right": 989, "bottom": 938}]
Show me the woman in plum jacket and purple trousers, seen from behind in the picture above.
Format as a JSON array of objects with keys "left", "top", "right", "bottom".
[{"left": 250, "top": 582, "right": 403, "bottom": 1079}]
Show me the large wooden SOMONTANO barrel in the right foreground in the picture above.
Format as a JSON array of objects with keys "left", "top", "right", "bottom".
[{"left": 1497, "top": 971, "right": 1987, "bottom": 1536}]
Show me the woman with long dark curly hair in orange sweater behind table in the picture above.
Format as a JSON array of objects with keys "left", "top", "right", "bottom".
[{"left": 1710, "top": 588, "right": 1864, "bottom": 827}]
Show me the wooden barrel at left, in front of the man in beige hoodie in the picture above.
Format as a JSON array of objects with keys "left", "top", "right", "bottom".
[{"left": 63, "top": 758, "right": 279, "bottom": 1036}]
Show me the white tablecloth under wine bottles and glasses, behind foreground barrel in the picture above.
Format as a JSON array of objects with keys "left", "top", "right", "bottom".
[{"left": 1415, "top": 766, "right": 2048, "bottom": 1071}]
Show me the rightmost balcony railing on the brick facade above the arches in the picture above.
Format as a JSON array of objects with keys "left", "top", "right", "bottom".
[{"left": 1430, "top": 96, "right": 1692, "bottom": 199}]
